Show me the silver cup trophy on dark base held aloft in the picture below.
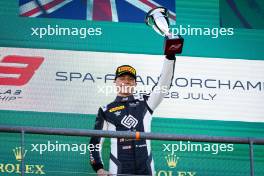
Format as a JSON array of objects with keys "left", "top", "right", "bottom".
[{"left": 145, "top": 7, "right": 183, "bottom": 55}]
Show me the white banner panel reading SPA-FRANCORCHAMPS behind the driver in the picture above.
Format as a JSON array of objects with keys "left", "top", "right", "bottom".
[{"left": 0, "top": 48, "right": 264, "bottom": 122}]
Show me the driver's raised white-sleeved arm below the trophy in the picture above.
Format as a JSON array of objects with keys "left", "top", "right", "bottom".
[{"left": 147, "top": 55, "right": 176, "bottom": 111}]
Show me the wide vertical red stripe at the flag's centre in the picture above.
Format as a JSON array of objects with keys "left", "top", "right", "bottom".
[{"left": 93, "top": 0, "right": 112, "bottom": 21}]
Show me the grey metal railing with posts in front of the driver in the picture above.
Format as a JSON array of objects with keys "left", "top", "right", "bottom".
[{"left": 0, "top": 125, "right": 264, "bottom": 176}]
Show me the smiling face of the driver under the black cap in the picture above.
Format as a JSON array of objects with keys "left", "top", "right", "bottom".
[{"left": 115, "top": 74, "right": 137, "bottom": 97}]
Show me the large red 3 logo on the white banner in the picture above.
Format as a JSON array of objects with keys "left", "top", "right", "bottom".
[{"left": 0, "top": 55, "right": 44, "bottom": 86}]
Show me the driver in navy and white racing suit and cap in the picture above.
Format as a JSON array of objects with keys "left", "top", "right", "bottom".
[{"left": 90, "top": 55, "right": 176, "bottom": 176}]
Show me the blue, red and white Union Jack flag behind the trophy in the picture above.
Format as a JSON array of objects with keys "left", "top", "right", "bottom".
[{"left": 19, "top": 0, "right": 176, "bottom": 24}]
